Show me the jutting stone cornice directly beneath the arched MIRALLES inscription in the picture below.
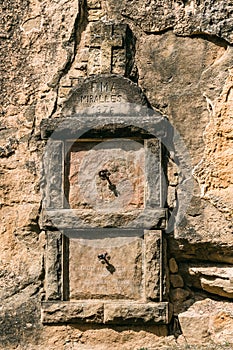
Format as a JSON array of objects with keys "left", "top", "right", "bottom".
[{"left": 40, "top": 115, "right": 167, "bottom": 142}]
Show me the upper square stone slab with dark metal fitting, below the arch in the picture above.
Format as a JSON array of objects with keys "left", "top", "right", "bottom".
[{"left": 67, "top": 139, "right": 145, "bottom": 211}]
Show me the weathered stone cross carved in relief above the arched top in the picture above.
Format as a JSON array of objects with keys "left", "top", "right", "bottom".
[{"left": 90, "top": 23, "right": 126, "bottom": 73}]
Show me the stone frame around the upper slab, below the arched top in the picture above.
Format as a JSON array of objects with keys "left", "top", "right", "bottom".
[{"left": 42, "top": 115, "right": 166, "bottom": 229}]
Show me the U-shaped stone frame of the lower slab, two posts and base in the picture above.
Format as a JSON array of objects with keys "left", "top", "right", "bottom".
[{"left": 42, "top": 230, "right": 172, "bottom": 325}]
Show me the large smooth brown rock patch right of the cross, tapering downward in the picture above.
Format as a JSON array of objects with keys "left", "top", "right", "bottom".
[{"left": 137, "top": 32, "right": 232, "bottom": 165}]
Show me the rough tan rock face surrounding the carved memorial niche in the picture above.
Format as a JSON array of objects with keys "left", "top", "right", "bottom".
[{"left": 0, "top": 0, "right": 233, "bottom": 350}]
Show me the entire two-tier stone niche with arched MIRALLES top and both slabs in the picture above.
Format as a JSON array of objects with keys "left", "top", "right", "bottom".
[{"left": 41, "top": 75, "right": 171, "bottom": 324}]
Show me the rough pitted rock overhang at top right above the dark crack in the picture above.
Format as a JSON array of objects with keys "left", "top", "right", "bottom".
[{"left": 110, "top": 0, "right": 233, "bottom": 43}]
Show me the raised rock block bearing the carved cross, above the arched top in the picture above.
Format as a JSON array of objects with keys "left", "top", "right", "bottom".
[{"left": 58, "top": 21, "right": 136, "bottom": 104}]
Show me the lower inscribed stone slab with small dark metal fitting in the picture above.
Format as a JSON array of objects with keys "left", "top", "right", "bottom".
[{"left": 69, "top": 237, "right": 143, "bottom": 300}]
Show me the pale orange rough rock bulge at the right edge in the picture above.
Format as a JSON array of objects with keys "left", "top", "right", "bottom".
[{"left": 194, "top": 69, "right": 233, "bottom": 221}]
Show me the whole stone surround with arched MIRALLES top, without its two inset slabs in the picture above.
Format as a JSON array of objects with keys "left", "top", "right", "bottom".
[{"left": 41, "top": 75, "right": 172, "bottom": 324}]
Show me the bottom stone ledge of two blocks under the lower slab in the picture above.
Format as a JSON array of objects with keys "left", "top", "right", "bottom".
[{"left": 42, "top": 300, "right": 172, "bottom": 325}]
